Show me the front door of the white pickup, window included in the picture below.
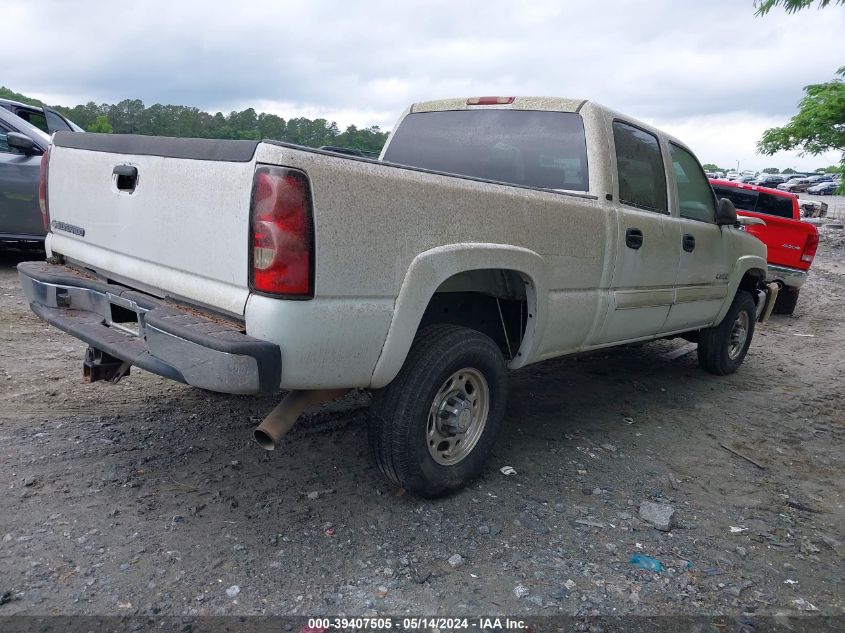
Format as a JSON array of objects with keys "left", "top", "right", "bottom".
[{"left": 664, "top": 142, "right": 730, "bottom": 332}]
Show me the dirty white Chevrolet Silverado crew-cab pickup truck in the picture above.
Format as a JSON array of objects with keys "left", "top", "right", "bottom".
[{"left": 19, "top": 97, "right": 772, "bottom": 496}]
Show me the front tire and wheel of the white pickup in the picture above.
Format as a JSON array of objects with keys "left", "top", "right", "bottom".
[{"left": 698, "top": 290, "right": 757, "bottom": 376}]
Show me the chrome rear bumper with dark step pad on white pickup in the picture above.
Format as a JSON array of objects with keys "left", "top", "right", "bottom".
[{"left": 18, "top": 262, "right": 282, "bottom": 394}]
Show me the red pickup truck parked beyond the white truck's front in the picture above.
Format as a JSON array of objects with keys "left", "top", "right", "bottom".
[{"left": 710, "top": 179, "right": 819, "bottom": 314}]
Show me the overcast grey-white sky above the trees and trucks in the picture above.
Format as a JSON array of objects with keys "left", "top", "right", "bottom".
[{"left": 6, "top": 0, "right": 845, "bottom": 169}]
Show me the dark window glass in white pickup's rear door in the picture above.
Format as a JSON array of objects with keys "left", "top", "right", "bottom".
[{"left": 613, "top": 121, "right": 669, "bottom": 213}]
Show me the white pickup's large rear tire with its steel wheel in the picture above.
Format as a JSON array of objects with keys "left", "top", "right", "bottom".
[{"left": 369, "top": 325, "right": 507, "bottom": 497}]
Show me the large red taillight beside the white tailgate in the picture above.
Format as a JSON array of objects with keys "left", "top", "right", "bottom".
[{"left": 251, "top": 167, "right": 314, "bottom": 297}]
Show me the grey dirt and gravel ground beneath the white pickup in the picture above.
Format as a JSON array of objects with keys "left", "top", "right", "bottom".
[{"left": 0, "top": 225, "right": 845, "bottom": 630}]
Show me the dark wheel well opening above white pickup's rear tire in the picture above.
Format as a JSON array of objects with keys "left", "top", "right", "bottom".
[{"left": 420, "top": 269, "right": 535, "bottom": 360}]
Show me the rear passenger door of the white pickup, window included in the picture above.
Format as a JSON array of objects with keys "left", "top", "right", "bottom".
[{"left": 594, "top": 120, "right": 681, "bottom": 344}]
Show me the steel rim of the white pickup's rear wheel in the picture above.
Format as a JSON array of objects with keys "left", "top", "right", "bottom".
[{"left": 426, "top": 367, "right": 490, "bottom": 466}]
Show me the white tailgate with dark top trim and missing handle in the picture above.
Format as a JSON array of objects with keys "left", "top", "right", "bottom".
[{"left": 42, "top": 132, "right": 258, "bottom": 314}]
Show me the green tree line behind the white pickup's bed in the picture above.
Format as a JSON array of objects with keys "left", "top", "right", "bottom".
[{"left": 0, "top": 87, "right": 387, "bottom": 153}]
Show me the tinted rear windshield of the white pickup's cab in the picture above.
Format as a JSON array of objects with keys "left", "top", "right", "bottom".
[{"left": 384, "top": 109, "right": 589, "bottom": 191}]
